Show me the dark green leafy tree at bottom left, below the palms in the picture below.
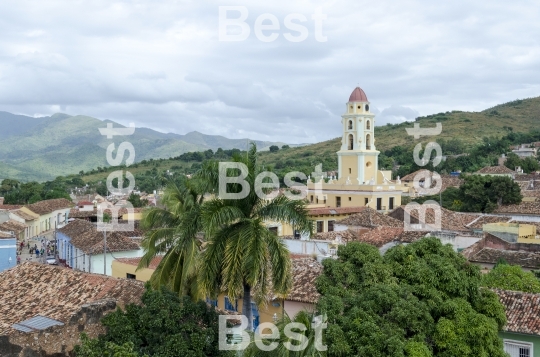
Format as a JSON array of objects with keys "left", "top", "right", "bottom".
[{"left": 74, "top": 287, "right": 231, "bottom": 357}]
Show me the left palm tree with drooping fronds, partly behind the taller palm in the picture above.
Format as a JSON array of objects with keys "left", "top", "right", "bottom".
[{"left": 137, "top": 177, "right": 203, "bottom": 299}]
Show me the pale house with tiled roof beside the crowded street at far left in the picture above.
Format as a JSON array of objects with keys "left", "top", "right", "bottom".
[{"left": 21, "top": 198, "right": 73, "bottom": 235}]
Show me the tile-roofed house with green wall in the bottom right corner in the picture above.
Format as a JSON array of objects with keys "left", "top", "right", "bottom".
[{"left": 495, "top": 290, "right": 540, "bottom": 357}]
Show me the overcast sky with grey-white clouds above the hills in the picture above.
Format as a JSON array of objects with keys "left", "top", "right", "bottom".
[{"left": 0, "top": 0, "right": 540, "bottom": 143}]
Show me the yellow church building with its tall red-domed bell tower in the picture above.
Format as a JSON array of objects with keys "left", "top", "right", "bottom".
[{"left": 307, "top": 87, "right": 403, "bottom": 212}]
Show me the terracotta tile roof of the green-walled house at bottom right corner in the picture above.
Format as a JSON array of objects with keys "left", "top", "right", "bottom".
[{"left": 494, "top": 289, "right": 540, "bottom": 335}]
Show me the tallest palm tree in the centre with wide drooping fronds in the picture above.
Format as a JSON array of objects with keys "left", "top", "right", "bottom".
[{"left": 199, "top": 145, "right": 312, "bottom": 329}]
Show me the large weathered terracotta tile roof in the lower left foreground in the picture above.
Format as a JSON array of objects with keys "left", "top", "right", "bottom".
[{"left": 0, "top": 262, "right": 144, "bottom": 336}]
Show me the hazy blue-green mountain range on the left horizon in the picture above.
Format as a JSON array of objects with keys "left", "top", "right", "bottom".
[{"left": 0, "top": 112, "right": 295, "bottom": 181}]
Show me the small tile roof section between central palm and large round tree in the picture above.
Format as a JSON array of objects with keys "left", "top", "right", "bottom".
[{"left": 286, "top": 258, "right": 323, "bottom": 304}]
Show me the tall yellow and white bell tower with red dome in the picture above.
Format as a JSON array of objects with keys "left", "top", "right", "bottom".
[{"left": 337, "top": 87, "right": 379, "bottom": 185}]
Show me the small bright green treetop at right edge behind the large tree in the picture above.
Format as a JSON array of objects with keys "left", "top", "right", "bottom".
[{"left": 482, "top": 264, "right": 540, "bottom": 294}]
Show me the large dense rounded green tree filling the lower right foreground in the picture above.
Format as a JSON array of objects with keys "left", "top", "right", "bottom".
[{"left": 317, "top": 238, "right": 506, "bottom": 357}]
